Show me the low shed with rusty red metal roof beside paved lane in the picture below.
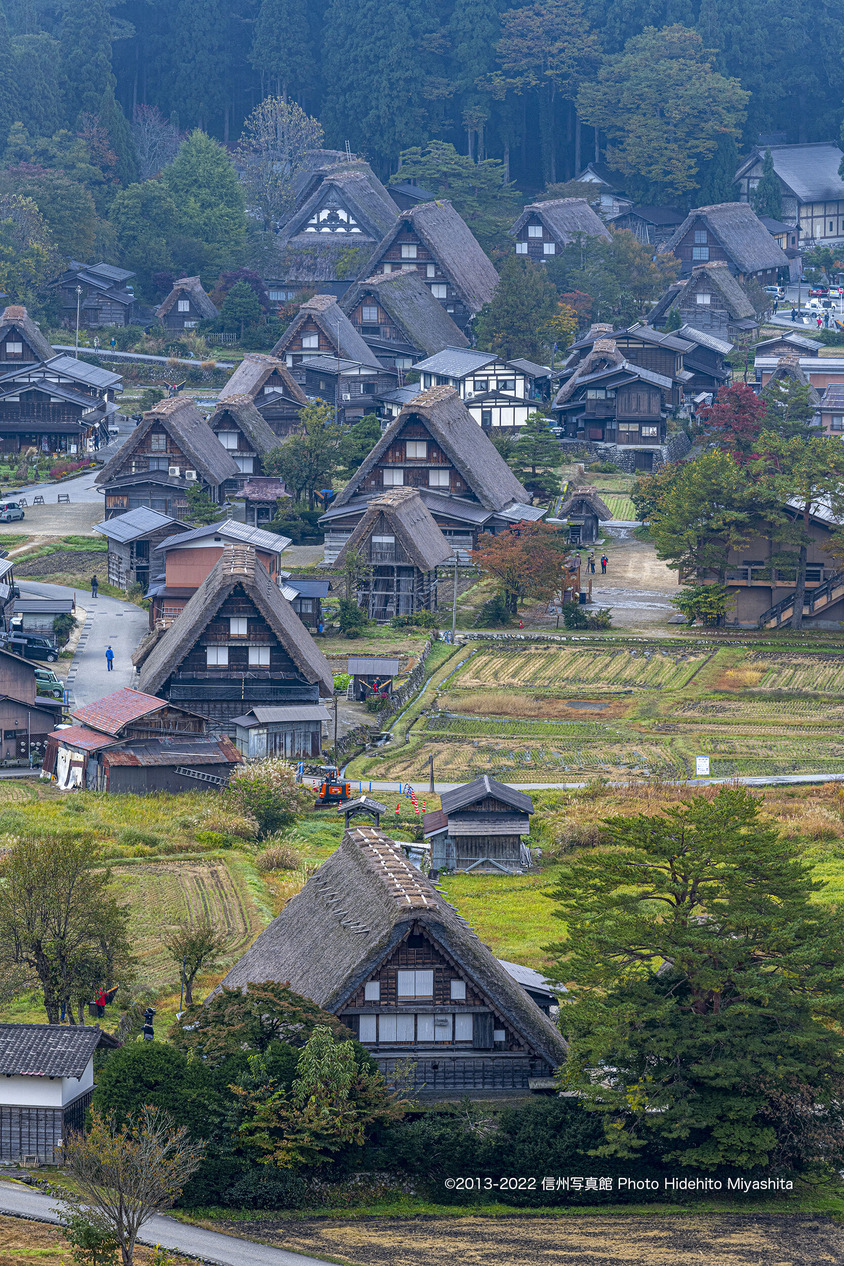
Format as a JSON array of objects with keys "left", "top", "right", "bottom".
[{"left": 42, "top": 689, "right": 240, "bottom": 795}]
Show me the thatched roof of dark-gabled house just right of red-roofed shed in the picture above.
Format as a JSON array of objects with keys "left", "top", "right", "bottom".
[{"left": 138, "top": 544, "right": 334, "bottom": 696}]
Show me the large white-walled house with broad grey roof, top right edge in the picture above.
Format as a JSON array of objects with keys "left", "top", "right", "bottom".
[{"left": 735, "top": 141, "right": 844, "bottom": 249}]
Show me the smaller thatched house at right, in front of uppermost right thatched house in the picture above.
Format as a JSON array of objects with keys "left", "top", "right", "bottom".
[{"left": 648, "top": 261, "right": 759, "bottom": 343}]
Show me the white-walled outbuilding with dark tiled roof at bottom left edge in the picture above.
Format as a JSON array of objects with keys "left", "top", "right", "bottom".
[{"left": 0, "top": 1024, "right": 120, "bottom": 1165}]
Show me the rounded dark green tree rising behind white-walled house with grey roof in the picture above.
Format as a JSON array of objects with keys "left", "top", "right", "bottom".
[{"left": 475, "top": 254, "right": 557, "bottom": 362}]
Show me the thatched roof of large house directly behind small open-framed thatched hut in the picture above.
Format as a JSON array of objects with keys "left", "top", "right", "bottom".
[{"left": 332, "top": 387, "right": 530, "bottom": 510}]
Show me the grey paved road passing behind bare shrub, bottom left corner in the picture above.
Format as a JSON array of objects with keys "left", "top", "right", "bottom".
[{"left": 0, "top": 1181, "right": 328, "bottom": 1266}]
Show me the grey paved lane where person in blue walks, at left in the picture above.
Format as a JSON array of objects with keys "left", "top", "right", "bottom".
[{"left": 19, "top": 576, "right": 149, "bottom": 706}]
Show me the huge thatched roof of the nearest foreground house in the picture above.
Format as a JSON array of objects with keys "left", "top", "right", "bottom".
[{"left": 221, "top": 825, "right": 567, "bottom": 1067}]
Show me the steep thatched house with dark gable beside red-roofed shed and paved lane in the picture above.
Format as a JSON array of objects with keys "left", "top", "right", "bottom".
[{"left": 139, "top": 544, "right": 334, "bottom": 733}]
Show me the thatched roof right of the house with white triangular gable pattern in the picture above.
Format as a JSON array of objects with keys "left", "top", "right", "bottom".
[{"left": 366, "top": 201, "right": 499, "bottom": 313}]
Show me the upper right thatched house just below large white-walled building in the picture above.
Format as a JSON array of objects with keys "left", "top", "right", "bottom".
[{"left": 659, "top": 203, "right": 788, "bottom": 286}]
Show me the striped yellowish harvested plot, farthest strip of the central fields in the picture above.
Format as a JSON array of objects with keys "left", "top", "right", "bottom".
[{"left": 445, "top": 646, "right": 708, "bottom": 691}]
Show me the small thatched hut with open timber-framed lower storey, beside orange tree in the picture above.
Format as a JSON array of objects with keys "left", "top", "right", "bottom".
[{"left": 335, "top": 487, "right": 453, "bottom": 624}]
